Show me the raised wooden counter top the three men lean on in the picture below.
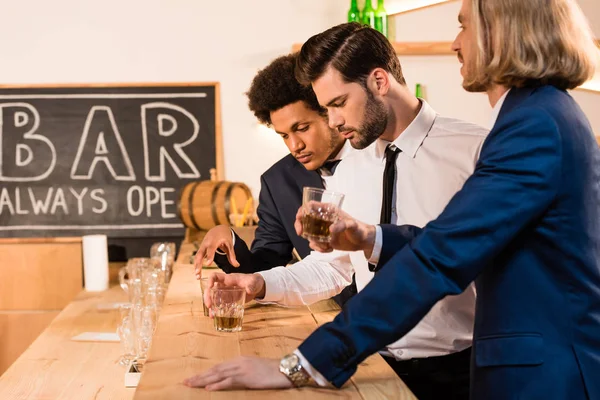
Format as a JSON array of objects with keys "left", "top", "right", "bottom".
[{"left": 134, "top": 264, "right": 415, "bottom": 400}]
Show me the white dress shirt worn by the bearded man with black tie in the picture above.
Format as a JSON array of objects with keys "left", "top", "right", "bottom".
[{"left": 260, "top": 101, "right": 487, "bottom": 384}]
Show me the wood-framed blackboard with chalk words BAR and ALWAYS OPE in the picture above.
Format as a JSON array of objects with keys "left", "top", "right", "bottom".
[{"left": 0, "top": 83, "right": 221, "bottom": 238}]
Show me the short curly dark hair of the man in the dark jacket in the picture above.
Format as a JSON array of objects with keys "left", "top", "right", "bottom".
[{"left": 246, "top": 53, "right": 326, "bottom": 125}]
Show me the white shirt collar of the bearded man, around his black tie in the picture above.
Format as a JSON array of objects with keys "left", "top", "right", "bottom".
[{"left": 375, "top": 99, "right": 437, "bottom": 158}]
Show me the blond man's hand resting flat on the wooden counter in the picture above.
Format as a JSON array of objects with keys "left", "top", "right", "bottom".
[{"left": 183, "top": 357, "right": 293, "bottom": 391}]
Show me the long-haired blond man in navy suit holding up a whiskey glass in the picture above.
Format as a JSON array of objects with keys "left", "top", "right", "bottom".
[{"left": 183, "top": 0, "right": 600, "bottom": 400}]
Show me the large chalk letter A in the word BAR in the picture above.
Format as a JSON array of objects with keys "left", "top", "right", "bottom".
[{"left": 71, "top": 106, "right": 135, "bottom": 181}]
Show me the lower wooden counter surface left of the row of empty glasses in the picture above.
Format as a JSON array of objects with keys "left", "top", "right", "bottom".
[{"left": 0, "top": 287, "right": 134, "bottom": 400}]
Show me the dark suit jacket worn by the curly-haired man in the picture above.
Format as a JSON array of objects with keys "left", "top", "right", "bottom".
[{"left": 215, "top": 154, "right": 323, "bottom": 273}]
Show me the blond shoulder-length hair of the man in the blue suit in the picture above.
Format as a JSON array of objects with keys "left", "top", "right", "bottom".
[{"left": 465, "top": 0, "right": 600, "bottom": 89}]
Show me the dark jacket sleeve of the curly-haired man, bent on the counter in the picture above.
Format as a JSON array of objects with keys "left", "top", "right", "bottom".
[{"left": 215, "top": 175, "right": 294, "bottom": 273}]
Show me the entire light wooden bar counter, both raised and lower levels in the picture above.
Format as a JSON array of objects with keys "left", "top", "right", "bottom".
[{"left": 0, "top": 239, "right": 415, "bottom": 400}]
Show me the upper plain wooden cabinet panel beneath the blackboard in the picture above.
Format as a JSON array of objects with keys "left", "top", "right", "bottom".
[{"left": 0, "top": 240, "right": 83, "bottom": 310}]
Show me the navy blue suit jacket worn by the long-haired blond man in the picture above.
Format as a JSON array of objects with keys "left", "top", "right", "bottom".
[{"left": 299, "top": 86, "right": 600, "bottom": 400}]
